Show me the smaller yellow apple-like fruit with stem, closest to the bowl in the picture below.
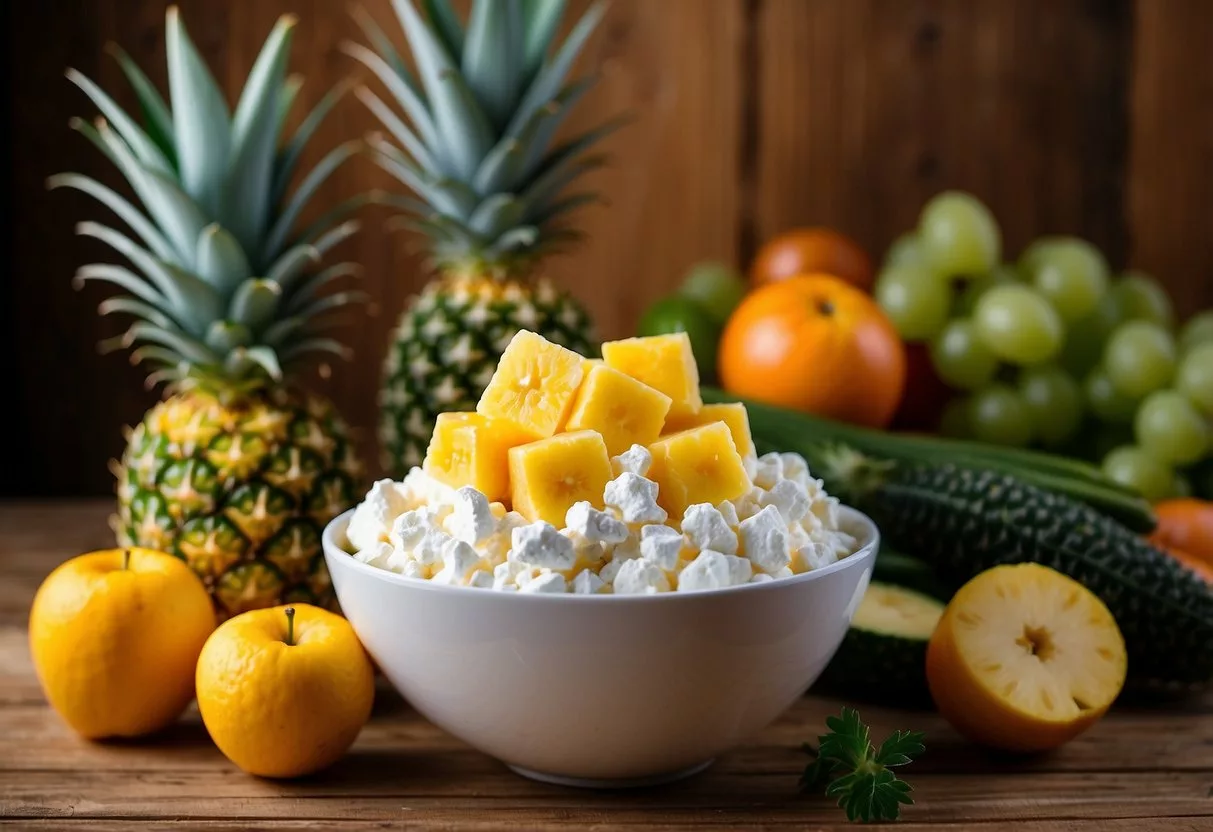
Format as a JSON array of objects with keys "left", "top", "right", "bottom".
[{"left": 197, "top": 604, "right": 375, "bottom": 777}]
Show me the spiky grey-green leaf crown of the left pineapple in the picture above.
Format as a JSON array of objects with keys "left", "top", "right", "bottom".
[{"left": 47, "top": 7, "right": 371, "bottom": 389}]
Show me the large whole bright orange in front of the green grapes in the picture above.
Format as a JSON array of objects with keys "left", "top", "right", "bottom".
[{"left": 719, "top": 274, "right": 906, "bottom": 428}]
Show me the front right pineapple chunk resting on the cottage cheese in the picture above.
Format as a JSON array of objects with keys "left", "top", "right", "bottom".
[{"left": 648, "top": 422, "right": 752, "bottom": 518}]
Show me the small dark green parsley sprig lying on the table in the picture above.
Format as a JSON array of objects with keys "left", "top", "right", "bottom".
[{"left": 801, "top": 708, "right": 927, "bottom": 824}]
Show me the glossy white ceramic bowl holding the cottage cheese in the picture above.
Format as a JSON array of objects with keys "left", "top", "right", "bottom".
[{"left": 324, "top": 508, "right": 879, "bottom": 786}]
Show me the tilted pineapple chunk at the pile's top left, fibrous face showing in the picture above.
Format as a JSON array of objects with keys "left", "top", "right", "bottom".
[{"left": 475, "top": 330, "right": 590, "bottom": 439}]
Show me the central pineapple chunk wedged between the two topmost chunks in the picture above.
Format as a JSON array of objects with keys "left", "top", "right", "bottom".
[{"left": 565, "top": 365, "right": 670, "bottom": 456}]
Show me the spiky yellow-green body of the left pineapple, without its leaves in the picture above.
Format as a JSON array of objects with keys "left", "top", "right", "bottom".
[{"left": 114, "top": 389, "right": 360, "bottom": 620}]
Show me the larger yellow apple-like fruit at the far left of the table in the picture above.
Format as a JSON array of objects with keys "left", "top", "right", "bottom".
[{"left": 29, "top": 548, "right": 215, "bottom": 739}]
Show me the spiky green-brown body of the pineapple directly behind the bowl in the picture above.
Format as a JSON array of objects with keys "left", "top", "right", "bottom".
[{"left": 380, "top": 277, "right": 598, "bottom": 478}]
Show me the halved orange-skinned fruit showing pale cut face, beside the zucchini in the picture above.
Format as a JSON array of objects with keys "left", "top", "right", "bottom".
[{"left": 927, "top": 563, "right": 1128, "bottom": 751}]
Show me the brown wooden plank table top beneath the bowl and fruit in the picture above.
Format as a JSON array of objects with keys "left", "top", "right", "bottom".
[{"left": 0, "top": 501, "right": 1213, "bottom": 832}]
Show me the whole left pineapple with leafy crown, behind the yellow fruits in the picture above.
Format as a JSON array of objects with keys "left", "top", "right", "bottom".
[{"left": 50, "top": 8, "right": 359, "bottom": 617}]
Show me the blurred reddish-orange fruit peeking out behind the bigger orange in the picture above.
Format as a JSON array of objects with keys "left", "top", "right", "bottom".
[{"left": 750, "top": 228, "right": 876, "bottom": 291}]
